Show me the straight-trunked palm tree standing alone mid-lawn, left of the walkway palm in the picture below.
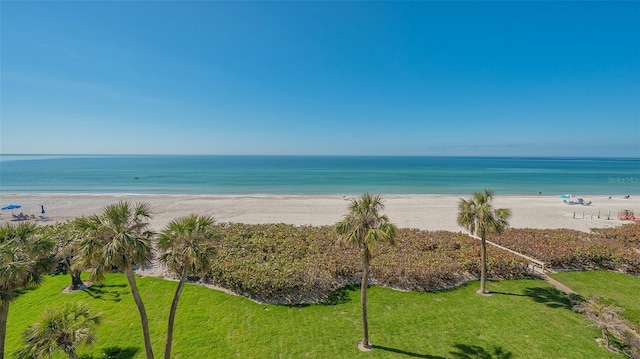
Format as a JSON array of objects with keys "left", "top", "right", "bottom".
[{"left": 336, "top": 193, "right": 397, "bottom": 350}]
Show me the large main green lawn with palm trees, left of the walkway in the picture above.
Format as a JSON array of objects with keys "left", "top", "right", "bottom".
[{"left": 6, "top": 274, "right": 619, "bottom": 359}]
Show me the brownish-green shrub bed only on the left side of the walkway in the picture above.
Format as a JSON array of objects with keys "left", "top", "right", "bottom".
[{"left": 208, "top": 223, "right": 530, "bottom": 304}]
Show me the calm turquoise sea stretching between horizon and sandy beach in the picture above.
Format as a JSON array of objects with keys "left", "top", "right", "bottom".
[{"left": 0, "top": 155, "right": 640, "bottom": 195}]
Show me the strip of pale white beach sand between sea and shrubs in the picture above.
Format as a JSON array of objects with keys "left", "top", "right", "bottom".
[{"left": 0, "top": 194, "right": 640, "bottom": 231}]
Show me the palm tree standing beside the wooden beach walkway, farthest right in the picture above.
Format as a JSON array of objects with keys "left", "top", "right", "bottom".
[{"left": 458, "top": 189, "right": 511, "bottom": 294}]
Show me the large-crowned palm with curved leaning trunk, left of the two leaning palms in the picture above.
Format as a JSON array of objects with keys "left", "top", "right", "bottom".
[{"left": 76, "top": 201, "right": 153, "bottom": 359}]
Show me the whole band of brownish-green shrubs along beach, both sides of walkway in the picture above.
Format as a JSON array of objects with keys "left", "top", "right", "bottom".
[{"left": 208, "top": 223, "right": 640, "bottom": 304}]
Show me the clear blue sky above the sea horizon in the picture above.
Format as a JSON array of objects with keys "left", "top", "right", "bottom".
[{"left": 0, "top": 1, "right": 640, "bottom": 157}]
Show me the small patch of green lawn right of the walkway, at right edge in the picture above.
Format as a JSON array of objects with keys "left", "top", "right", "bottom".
[{"left": 552, "top": 271, "right": 640, "bottom": 325}]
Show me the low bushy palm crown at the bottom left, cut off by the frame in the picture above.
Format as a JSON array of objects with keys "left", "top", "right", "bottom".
[{"left": 16, "top": 302, "right": 101, "bottom": 359}]
